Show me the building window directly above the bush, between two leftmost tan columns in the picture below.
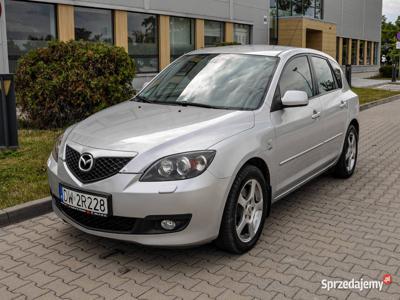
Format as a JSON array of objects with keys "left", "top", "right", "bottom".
[{"left": 75, "top": 7, "right": 114, "bottom": 44}]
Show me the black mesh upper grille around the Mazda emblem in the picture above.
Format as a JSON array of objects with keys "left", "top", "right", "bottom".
[{"left": 65, "top": 146, "right": 132, "bottom": 183}]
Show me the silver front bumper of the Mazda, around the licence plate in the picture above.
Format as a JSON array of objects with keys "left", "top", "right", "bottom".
[{"left": 48, "top": 156, "right": 230, "bottom": 247}]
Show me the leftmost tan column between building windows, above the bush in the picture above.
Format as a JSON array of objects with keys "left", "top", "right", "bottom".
[{"left": 57, "top": 4, "right": 75, "bottom": 42}]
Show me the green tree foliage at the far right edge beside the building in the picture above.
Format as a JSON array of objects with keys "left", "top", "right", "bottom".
[{"left": 381, "top": 16, "right": 400, "bottom": 64}]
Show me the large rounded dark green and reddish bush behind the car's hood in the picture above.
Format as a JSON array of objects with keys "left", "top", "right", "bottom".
[{"left": 16, "top": 41, "right": 135, "bottom": 129}]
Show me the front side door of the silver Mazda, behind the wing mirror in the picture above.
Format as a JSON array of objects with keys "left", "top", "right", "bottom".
[{"left": 271, "top": 55, "right": 323, "bottom": 197}]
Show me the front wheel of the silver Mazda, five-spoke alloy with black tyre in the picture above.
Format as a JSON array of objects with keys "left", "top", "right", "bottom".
[{"left": 215, "top": 165, "right": 271, "bottom": 254}]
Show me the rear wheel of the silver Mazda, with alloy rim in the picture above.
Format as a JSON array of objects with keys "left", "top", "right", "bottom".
[{"left": 333, "top": 125, "right": 358, "bottom": 179}]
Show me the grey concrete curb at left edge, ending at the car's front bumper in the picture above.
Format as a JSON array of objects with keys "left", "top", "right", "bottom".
[{"left": 0, "top": 197, "right": 51, "bottom": 227}]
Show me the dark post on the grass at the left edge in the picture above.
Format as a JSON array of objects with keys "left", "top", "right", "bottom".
[{"left": 0, "top": 74, "right": 18, "bottom": 150}]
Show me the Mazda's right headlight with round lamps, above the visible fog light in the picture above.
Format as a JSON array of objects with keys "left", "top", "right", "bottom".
[{"left": 140, "top": 150, "right": 215, "bottom": 182}]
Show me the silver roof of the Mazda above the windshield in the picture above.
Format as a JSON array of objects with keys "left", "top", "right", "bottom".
[{"left": 189, "top": 45, "right": 333, "bottom": 59}]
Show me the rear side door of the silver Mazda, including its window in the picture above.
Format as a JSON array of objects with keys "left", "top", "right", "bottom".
[{"left": 311, "top": 55, "right": 348, "bottom": 165}]
